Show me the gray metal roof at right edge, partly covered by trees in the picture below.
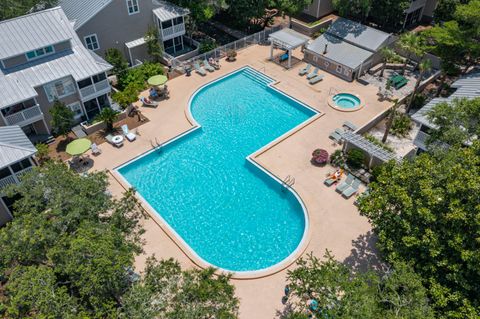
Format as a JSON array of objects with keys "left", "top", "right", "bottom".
[{"left": 412, "top": 70, "right": 480, "bottom": 128}]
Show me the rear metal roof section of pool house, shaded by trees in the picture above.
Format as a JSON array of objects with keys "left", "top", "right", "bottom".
[{"left": 327, "top": 18, "right": 390, "bottom": 52}]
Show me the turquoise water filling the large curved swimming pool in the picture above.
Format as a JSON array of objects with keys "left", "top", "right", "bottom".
[{"left": 118, "top": 68, "right": 315, "bottom": 271}]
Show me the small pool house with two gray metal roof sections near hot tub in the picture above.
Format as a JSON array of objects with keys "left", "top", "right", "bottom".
[{"left": 304, "top": 18, "right": 394, "bottom": 81}]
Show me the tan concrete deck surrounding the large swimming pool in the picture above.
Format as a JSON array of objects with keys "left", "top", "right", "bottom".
[{"left": 91, "top": 45, "right": 391, "bottom": 319}]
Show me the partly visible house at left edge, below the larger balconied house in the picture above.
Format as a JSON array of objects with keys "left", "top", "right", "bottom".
[{"left": 0, "top": 125, "right": 37, "bottom": 226}]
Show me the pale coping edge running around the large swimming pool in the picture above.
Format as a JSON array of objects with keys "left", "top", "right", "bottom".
[{"left": 111, "top": 64, "right": 324, "bottom": 279}]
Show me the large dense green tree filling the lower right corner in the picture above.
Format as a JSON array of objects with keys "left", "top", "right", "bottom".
[{"left": 359, "top": 142, "right": 480, "bottom": 318}]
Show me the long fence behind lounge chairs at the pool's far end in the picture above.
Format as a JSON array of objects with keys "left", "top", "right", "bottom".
[{"left": 169, "top": 26, "right": 283, "bottom": 72}]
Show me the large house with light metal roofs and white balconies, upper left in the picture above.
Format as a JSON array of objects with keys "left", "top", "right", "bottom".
[{"left": 0, "top": 7, "right": 112, "bottom": 141}]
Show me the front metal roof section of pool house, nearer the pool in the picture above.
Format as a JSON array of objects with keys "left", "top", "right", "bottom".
[{"left": 307, "top": 33, "right": 373, "bottom": 69}]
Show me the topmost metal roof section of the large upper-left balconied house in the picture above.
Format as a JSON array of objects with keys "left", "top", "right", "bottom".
[{"left": 0, "top": 6, "right": 72, "bottom": 60}]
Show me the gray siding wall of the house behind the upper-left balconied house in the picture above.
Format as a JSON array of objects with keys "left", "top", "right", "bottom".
[{"left": 76, "top": 0, "right": 155, "bottom": 57}]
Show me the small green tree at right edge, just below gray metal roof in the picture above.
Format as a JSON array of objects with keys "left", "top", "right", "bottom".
[{"left": 427, "top": 98, "right": 480, "bottom": 147}]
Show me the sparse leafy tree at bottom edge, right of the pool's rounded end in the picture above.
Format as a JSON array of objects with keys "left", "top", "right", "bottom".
[{"left": 286, "top": 251, "right": 434, "bottom": 319}]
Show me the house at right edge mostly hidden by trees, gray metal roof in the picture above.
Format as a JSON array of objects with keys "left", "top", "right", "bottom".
[{"left": 412, "top": 71, "right": 480, "bottom": 152}]
